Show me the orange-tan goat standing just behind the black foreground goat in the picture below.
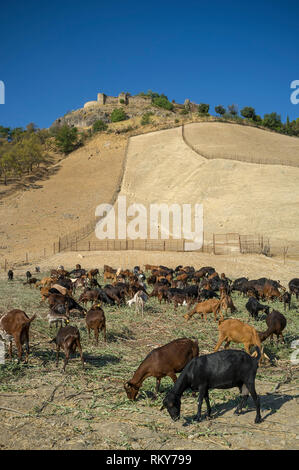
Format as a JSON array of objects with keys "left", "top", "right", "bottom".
[{"left": 214, "top": 318, "right": 263, "bottom": 364}]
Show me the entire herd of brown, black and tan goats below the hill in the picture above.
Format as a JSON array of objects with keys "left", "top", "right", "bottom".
[{"left": 0, "top": 264, "right": 299, "bottom": 423}]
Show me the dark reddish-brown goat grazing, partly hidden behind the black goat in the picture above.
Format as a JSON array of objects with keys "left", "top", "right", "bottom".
[{"left": 124, "top": 338, "right": 199, "bottom": 400}]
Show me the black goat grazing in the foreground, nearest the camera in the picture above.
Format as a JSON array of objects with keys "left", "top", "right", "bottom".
[{"left": 161, "top": 348, "right": 262, "bottom": 423}]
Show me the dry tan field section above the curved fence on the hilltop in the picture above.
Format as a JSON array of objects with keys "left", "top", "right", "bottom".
[{"left": 184, "top": 122, "right": 299, "bottom": 167}]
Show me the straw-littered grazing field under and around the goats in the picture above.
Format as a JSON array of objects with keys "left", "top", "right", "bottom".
[{"left": 0, "top": 271, "right": 299, "bottom": 450}]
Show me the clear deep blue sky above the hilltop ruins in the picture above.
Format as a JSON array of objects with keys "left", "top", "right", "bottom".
[{"left": 0, "top": 0, "right": 299, "bottom": 127}]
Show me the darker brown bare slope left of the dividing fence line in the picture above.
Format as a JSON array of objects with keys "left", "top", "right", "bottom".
[{"left": 0, "top": 134, "right": 126, "bottom": 261}]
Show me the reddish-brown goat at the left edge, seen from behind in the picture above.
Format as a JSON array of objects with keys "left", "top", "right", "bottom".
[{"left": 0, "top": 309, "right": 36, "bottom": 362}]
